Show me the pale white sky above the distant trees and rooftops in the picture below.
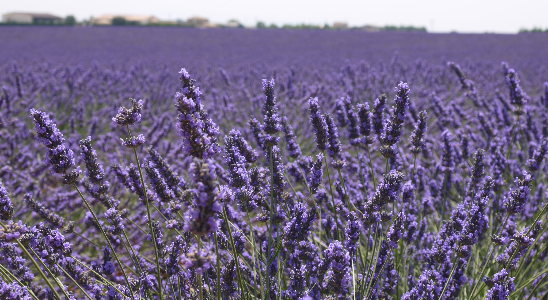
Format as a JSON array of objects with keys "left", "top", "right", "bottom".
[{"left": 0, "top": 0, "right": 548, "bottom": 33}]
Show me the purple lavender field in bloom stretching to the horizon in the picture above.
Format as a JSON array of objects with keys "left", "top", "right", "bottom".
[{"left": 0, "top": 26, "right": 548, "bottom": 300}]
